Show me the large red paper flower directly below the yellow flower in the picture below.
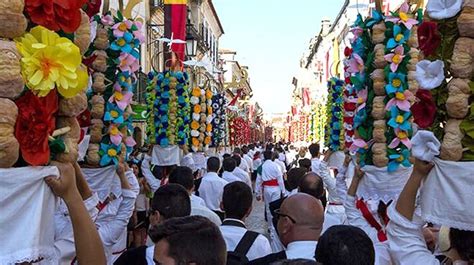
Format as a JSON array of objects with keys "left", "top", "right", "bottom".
[{"left": 15, "top": 90, "right": 58, "bottom": 166}]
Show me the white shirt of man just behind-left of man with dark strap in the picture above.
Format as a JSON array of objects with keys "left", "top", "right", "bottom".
[{"left": 199, "top": 172, "right": 228, "bottom": 211}]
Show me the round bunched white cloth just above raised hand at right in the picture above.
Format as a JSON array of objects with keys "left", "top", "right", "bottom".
[{"left": 411, "top": 130, "right": 441, "bottom": 162}]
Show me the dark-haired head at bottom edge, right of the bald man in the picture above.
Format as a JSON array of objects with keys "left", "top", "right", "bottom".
[{"left": 315, "top": 225, "right": 375, "bottom": 265}]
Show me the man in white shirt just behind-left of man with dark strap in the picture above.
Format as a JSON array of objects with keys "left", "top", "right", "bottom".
[{"left": 199, "top": 157, "right": 228, "bottom": 220}]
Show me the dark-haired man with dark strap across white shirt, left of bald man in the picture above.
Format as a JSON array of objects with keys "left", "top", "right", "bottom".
[{"left": 220, "top": 182, "right": 272, "bottom": 261}]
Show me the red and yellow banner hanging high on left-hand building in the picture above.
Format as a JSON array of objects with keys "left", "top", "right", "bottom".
[{"left": 164, "top": 0, "right": 188, "bottom": 61}]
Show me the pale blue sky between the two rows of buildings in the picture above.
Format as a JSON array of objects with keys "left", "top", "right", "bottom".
[{"left": 213, "top": 0, "right": 344, "bottom": 113}]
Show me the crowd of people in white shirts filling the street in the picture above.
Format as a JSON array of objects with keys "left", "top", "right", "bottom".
[{"left": 27, "top": 143, "right": 474, "bottom": 265}]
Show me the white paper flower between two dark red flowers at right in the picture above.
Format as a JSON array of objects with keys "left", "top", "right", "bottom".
[{"left": 415, "top": 60, "right": 445, "bottom": 90}]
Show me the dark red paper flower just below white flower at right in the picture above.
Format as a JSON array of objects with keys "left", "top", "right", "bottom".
[{"left": 411, "top": 89, "right": 436, "bottom": 129}]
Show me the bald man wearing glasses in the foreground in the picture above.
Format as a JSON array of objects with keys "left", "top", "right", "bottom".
[{"left": 249, "top": 193, "right": 324, "bottom": 265}]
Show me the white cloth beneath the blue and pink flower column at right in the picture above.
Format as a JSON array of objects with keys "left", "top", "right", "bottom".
[{"left": 357, "top": 166, "right": 413, "bottom": 203}]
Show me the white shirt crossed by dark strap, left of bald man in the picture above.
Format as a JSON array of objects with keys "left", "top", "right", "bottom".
[{"left": 219, "top": 218, "right": 272, "bottom": 261}]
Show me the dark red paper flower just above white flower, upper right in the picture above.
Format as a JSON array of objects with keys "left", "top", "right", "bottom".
[{"left": 418, "top": 21, "right": 441, "bottom": 56}]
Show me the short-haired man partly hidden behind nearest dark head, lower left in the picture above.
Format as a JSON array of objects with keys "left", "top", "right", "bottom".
[{"left": 114, "top": 184, "right": 191, "bottom": 265}]
